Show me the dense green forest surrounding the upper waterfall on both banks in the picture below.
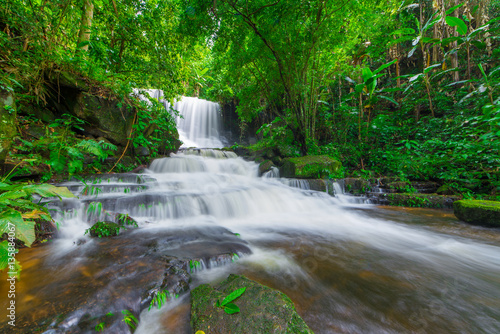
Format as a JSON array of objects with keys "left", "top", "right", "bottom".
[{"left": 0, "top": 0, "right": 500, "bottom": 253}]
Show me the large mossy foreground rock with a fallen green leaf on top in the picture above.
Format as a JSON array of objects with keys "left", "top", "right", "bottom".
[{"left": 191, "top": 275, "right": 313, "bottom": 334}]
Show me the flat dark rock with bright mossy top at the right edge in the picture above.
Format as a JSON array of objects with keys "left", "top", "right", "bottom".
[{"left": 453, "top": 200, "right": 500, "bottom": 227}]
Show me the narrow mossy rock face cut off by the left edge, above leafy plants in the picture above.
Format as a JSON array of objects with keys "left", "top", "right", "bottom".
[{"left": 0, "top": 90, "right": 17, "bottom": 172}]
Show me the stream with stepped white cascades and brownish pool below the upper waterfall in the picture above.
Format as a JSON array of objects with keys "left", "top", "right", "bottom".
[{"left": 0, "top": 98, "right": 500, "bottom": 334}]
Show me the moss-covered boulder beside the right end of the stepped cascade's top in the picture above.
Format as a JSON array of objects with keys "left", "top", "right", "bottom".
[{"left": 282, "top": 155, "right": 342, "bottom": 179}]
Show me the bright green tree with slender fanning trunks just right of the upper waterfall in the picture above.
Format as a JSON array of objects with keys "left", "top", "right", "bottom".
[{"left": 185, "top": 0, "right": 396, "bottom": 154}]
